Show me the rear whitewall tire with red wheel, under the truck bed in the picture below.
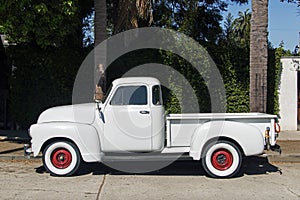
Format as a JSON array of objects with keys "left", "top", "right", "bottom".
[{"left": 202, "top": 141, "right": 242, "bottom": 178}]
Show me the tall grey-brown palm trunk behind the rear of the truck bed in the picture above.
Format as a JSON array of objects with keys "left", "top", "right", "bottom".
[{"left": 250, "top": 0, "right": 269, "bottom": 112}]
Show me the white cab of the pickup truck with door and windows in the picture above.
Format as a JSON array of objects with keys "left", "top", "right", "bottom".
[{"left": 95, "top": 77, "right": 165, "bottom": 152}]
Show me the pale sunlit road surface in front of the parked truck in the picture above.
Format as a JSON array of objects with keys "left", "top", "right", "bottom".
[{"left": 0, "top": 157, "right": 300, "bottom": 200}]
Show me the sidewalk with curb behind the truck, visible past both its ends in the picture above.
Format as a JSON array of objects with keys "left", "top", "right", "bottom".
[{"left": 0, "top": 131, "right": 300, "bottom": 163}]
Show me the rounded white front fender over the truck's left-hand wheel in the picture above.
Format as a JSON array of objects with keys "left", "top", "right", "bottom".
[{"left": 30, "top": 122, "right": 101, "bottom": 162}]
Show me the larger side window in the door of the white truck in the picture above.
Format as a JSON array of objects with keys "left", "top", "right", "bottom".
[{"left": 110, "top": 86, "right": 148, "bottom": 105}]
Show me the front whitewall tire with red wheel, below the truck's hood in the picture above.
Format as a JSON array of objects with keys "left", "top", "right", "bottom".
[{"left": 43, "top": 141, "right": 81, "bottom": 176}]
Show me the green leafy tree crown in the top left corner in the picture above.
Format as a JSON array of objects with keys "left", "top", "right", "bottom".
[{"left": 0, "top": 0, "right": 91, "bottom": 48}]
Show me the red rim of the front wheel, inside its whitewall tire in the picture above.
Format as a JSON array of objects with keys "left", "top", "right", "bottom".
[{"left": 51, "top": 148, "right": 72, "bottom": 169}]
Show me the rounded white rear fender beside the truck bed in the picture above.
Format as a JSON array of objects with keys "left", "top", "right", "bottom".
[{"left": 190, "top": 121, "right": 264, "bottom": 160}]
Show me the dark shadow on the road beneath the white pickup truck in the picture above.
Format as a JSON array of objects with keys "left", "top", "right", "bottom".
[{"left": 36, "top": 156, "right": 281, "bottom": 178}]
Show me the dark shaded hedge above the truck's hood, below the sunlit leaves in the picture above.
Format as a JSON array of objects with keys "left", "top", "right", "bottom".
[{"left": 10, "top": 45, "right": 85, "bottom": 129}]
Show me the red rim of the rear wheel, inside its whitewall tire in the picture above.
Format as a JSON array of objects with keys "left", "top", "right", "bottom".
[{"left": 211, "top": 149, "right": 233, "bottom": 171}]
